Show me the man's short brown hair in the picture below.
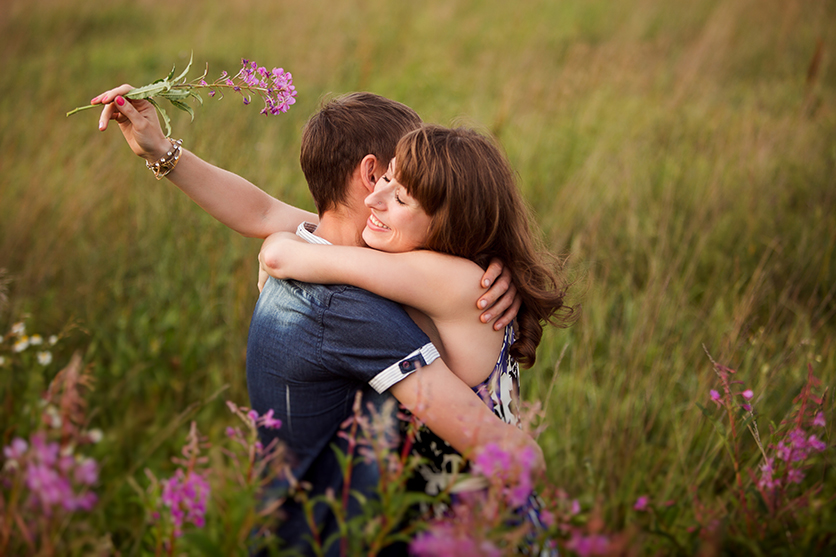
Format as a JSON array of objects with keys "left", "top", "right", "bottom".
[{"left": 299, "top": 93, "right": 421, "bottom": 215}]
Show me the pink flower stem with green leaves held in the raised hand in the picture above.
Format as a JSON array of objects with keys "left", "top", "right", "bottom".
[{"left": 67, "top": 54, "right": 296, "bottom": 135}]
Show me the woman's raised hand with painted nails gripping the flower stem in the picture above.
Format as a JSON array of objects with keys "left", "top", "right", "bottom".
[{"left": 90, "top": 83, "right": 171, "bottom": 162}]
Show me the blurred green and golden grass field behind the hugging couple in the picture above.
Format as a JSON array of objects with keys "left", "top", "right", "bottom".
[{"left": 0, "top": 0, "right": 836, "bottom": 555}]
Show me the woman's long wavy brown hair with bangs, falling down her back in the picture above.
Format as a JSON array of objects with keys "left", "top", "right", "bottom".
[{"left": 395, "top": 125, "right": 574, "bottom": 367}]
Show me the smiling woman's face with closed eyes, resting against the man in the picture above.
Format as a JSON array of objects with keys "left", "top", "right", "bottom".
[{"left": 363, "top": 159, "right": 432, "bottom": 252}]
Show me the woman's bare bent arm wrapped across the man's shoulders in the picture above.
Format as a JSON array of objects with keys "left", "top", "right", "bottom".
[{"left": 258, "top": 233, "right": 483, "bottom": 319}]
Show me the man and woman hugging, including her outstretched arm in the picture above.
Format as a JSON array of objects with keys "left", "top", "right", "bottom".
[{"left": 92, "top": 85, "right": 571, "bottom": 554}]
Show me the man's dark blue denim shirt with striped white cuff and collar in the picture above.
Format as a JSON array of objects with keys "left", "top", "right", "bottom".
[{"left": 247, "top": 223, "right": 438, "bottom": 545}]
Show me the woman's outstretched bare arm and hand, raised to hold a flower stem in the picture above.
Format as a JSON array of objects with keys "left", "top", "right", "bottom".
[{"left": 91, "top": 84, "right": 319, "bottom": 238}]
